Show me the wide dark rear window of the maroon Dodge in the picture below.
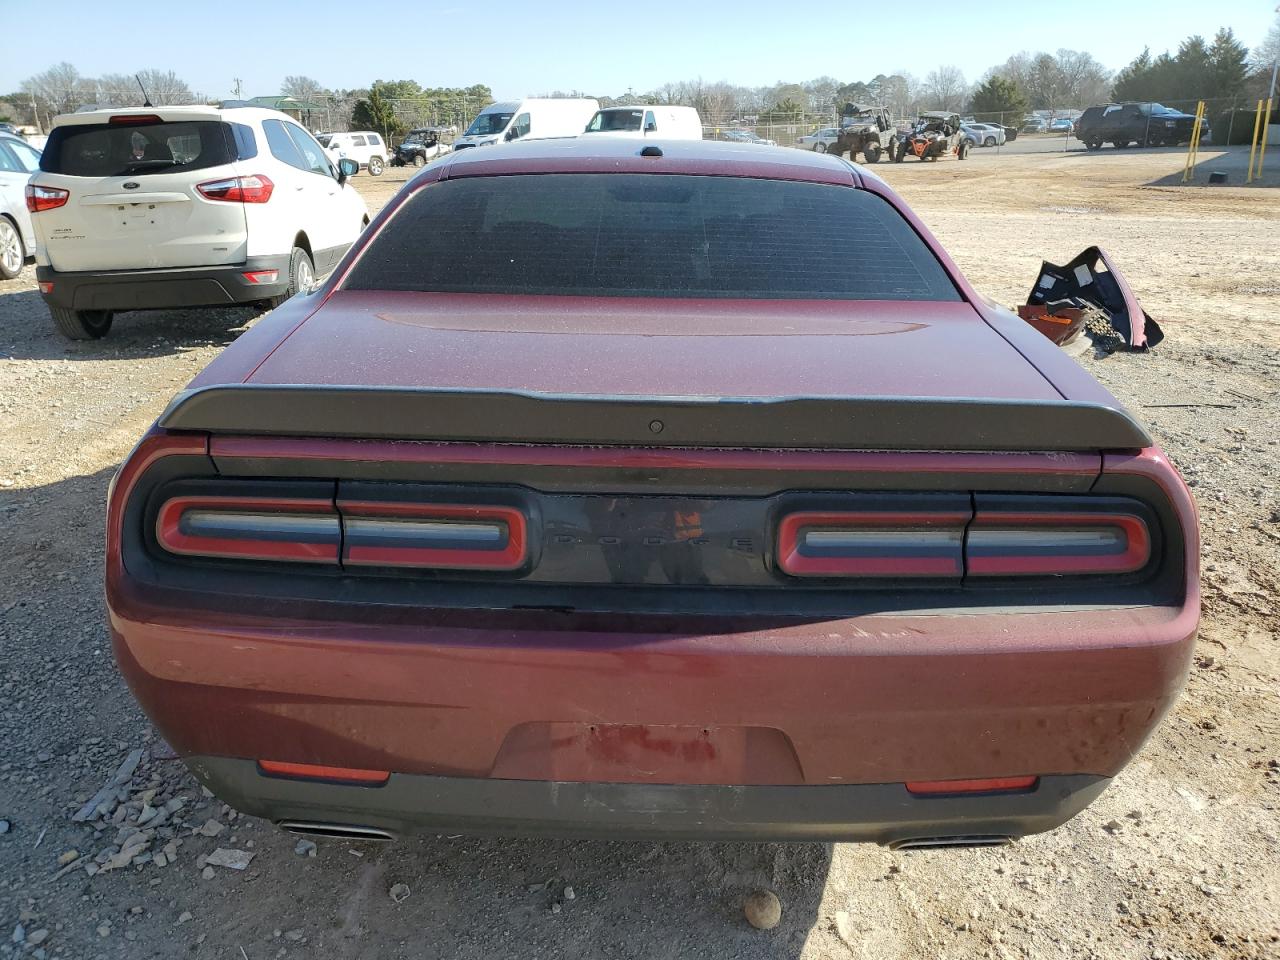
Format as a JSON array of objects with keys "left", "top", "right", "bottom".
[{"left": 343, "top": 174, "right": 960, "bottom": 301}]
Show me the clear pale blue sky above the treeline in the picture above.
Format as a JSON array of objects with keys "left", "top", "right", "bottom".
[{"left": 0, "top": 0, "right": 1277, "bottom": 97}]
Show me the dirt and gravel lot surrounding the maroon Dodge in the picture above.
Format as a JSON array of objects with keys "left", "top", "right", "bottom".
[{"left": 0, "top": 152, "right": 1280, "bottom": 960}]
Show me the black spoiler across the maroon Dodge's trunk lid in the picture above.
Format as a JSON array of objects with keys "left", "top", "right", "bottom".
[{"left": 160, "top": 384, "right": 1152, "bottom": 452}]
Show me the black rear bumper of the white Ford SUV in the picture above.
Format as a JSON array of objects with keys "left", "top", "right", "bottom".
[{"left": 36, "top": 253, "right": 289, "bottom": 311}]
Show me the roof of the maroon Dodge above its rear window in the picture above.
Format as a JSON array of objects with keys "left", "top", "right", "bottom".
[{"left": 430, "top": 137, "right": 859, "bottom": 186}]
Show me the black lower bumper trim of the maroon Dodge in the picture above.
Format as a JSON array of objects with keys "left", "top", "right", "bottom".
[{"left": 187, "top": 756, "right": 1110, "bottom": 845}]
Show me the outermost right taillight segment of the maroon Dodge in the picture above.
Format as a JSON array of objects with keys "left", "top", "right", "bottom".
[{"left": 965, "top": 511, "right": 1151, "bottom": 576}]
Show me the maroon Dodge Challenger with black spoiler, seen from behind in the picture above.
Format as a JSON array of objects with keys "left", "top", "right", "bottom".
[{"left": 106, "top": 140, "right": 1199, "bottom": 847}]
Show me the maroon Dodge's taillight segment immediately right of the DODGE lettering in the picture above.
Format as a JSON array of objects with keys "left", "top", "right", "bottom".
[{"left": 778, "top": 511, "right": 969, "bottom": 577}]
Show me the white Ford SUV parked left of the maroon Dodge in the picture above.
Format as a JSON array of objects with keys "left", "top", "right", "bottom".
[{"left": 27, "top": 106, "right": 369, "bottom": 339}]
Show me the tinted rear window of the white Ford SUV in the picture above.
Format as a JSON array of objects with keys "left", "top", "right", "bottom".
[{"left": 40, "top": 120, "right": 237, "bottom": 177}]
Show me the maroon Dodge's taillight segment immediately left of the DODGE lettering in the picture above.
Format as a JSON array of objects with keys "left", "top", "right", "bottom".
[{"left": 338, "top": 499, "right": 529, "bottom": 571}]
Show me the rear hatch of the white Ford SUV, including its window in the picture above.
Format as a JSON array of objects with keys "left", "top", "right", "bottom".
[{"left": 33, "top": 113, "right": 256, "bottom": 273}]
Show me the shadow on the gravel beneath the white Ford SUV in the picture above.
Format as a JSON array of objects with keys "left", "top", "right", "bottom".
[{"left": 0, "top": 289, "right": 260, "bottom": 360}]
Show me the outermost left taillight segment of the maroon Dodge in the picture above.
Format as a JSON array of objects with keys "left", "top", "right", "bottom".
[{"left": 156, "top": 497, "right": 342, "bottom": 563}]
